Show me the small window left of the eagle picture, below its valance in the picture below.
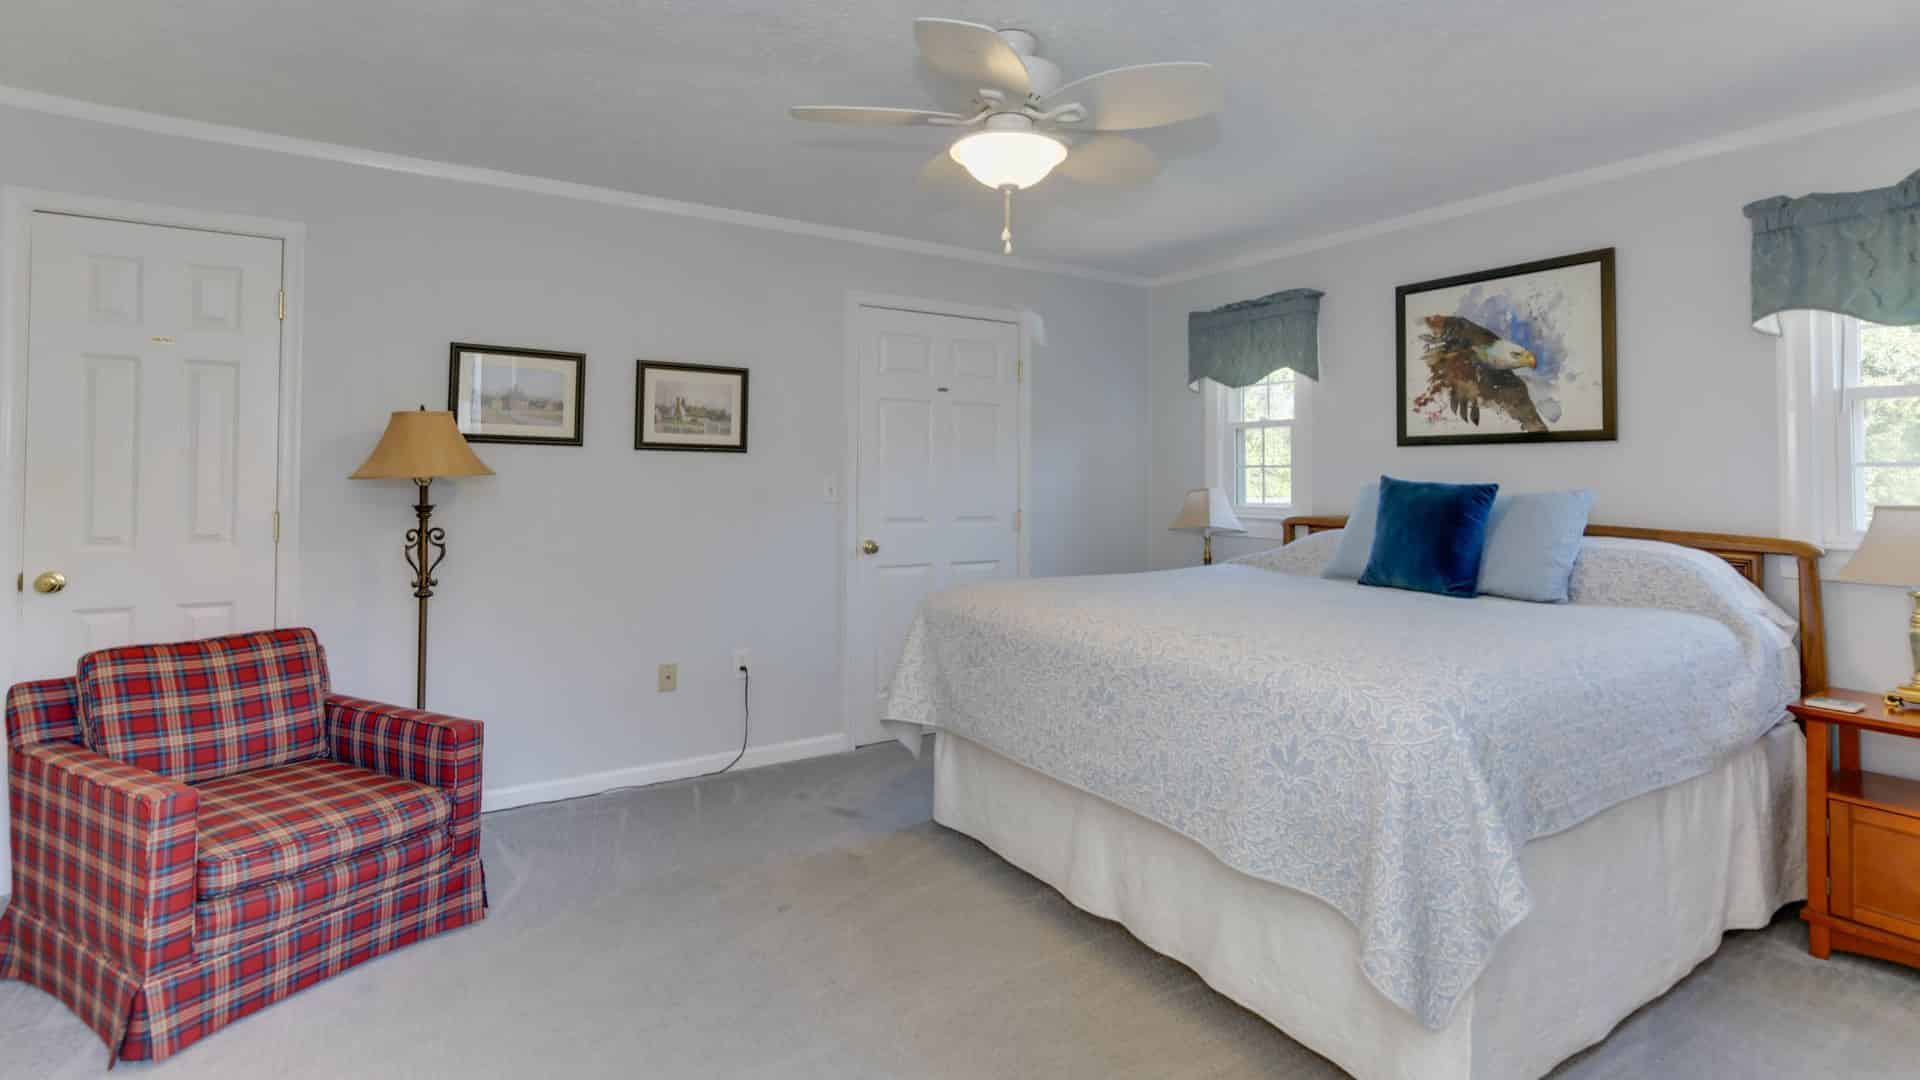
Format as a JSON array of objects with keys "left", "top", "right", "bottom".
[{"left": 1206, "top": 367, "right": 1311, "bottom": 536}]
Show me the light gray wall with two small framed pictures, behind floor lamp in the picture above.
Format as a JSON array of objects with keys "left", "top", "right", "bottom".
[{"left": 0, "top": 110, "right": 1148, "bottom": 803}]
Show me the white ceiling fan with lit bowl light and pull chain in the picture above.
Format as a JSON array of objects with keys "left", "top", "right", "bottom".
[{"left": 789, "top": 19, "right": 1223, "bottom": 256}]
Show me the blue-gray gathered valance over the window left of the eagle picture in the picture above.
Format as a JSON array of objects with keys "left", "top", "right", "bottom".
[{"left": 1187, "top": 288, "right": 1325, "bottom": 390}]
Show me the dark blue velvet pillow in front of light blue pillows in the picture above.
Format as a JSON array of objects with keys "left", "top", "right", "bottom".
[{"left": 1359, "top": 477, "right": 1500, "bottom": 596}]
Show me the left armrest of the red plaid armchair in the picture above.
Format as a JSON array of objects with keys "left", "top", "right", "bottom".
[{"left": 8, "top": 742, "right": 200, "bottom": 976}]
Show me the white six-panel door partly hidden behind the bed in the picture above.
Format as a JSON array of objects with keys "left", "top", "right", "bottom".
[{"left": 847, "top": 297, "right": 1020, "bottom": 744}]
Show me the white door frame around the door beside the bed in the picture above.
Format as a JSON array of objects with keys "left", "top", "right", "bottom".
[{"left": 839, "top": 292, "right": 1033, "bottom": 749}]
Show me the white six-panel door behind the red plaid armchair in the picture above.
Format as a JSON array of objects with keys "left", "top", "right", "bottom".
[{"left": 12, "top": 213, "right": 282, "bottom": 678}]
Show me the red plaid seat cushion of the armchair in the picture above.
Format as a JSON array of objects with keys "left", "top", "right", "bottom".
[{"left": 198, "top": 761, "right": 451, "bottom": 901}]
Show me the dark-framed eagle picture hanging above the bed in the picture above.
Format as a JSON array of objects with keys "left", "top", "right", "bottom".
[{"left": 1394, "top": 248, "right": 1619, "bottom": 446}]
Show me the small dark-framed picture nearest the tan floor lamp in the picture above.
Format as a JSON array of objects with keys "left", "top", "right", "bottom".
[{"left": 447, "top": 342, "right": 588, "bottom": 446}]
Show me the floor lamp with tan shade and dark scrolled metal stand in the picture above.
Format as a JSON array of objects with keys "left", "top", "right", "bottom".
[{"left": 349, "top": 405, "right": 493, "bottom": 709}]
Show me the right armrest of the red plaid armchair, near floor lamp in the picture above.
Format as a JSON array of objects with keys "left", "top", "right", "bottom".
[{"left": 326, "top": 694, "right": 482, "bottom": 859}]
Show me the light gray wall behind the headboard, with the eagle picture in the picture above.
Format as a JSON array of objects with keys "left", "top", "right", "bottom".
[{"left": 1148, "top": 105, "right": 1920, "bottom": 774}]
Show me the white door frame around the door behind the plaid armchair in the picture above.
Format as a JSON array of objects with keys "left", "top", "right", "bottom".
[{"left": 0, "top": 186, "right": 307, "bottom": 686}]
